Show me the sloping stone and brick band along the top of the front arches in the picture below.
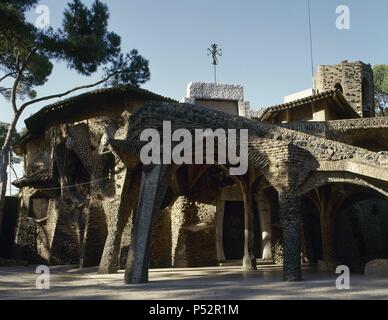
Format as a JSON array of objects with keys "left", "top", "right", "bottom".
[{"left": 119, "top": 102, "right": 388, "bottom": 190}]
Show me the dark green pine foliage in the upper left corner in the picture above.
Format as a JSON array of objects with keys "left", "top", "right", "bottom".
[{"left": 0, "top": 0, "right": 150, "bottom": 99}]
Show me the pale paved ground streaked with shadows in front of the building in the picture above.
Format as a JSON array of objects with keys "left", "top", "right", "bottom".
[{"left": 0, "top": 266, "right": 388, "bottom": 300}]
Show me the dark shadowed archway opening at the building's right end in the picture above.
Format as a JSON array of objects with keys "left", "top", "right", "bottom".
[{"left": 302, "top": 183, "right": 388, "bottom": 273}]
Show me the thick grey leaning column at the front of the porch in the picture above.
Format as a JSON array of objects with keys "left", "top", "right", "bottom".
[{"left": 125, "top": 165, "right": 167, "bottom": 284}]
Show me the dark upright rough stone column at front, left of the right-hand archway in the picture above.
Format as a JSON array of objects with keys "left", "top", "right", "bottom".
[{"left": 279, "top": 190, "right": 302, "bottom": 282}]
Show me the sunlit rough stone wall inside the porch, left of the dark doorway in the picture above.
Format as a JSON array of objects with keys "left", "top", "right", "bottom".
[{"left": 151, "top": 168, "right": 220, "bottom": 267}]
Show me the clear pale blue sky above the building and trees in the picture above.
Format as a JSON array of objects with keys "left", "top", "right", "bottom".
[{"left": 0, "top": 0, "right": 388, "bottom": 129}]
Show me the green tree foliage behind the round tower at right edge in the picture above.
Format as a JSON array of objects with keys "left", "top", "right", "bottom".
[{"left": 373, "top": 64, "right": 388, "bottom": 116}]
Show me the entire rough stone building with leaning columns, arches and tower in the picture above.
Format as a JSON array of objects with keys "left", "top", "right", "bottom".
[{"left": 9, "top": 61, "right": 388, "bottom": 283}]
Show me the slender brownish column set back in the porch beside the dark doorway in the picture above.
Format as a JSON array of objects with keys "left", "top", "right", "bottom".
[{"left": 243, "top": 188, "right": 256, "bottom": 271}]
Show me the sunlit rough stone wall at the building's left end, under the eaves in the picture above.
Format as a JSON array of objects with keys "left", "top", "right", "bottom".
[{"left": 16, "top": 107, "right": 135, "bottom": 266}]
